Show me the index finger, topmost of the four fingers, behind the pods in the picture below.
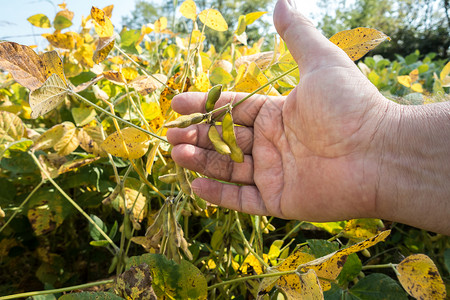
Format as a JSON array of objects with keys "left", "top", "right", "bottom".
[{"left": 172, "top": 92, "right": 276, "bottom": 126}]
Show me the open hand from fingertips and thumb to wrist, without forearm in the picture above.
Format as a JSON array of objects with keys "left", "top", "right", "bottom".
[{"left": 168, "top": 1, "right": 389, "bottom": 221}]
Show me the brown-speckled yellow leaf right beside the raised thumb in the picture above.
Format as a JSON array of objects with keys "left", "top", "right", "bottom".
[{"left": 330, "top": 27, "right": 390, "bottom": 60}]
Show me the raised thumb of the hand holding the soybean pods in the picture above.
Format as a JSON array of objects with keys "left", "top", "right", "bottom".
[{"left": 273, "top": 0, "right": 353, "bottom": 74}]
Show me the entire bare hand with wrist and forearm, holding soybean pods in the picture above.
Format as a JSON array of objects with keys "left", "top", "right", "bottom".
[{"left": 167, "top": 0, "right": 450, "bottom": 235}]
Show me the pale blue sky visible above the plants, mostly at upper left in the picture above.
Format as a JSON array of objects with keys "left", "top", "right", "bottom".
[{"left": 0, "top": 0, "right": 317, "bottom": 47}]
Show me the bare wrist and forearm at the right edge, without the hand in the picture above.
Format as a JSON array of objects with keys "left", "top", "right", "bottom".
[{"left": 377, "top": 102, "right": 450, "bottom": 235}]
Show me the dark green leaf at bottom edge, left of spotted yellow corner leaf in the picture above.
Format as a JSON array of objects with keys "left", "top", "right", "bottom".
[{"left": 349, "top": 273, "right": 408, "bottom": 300}]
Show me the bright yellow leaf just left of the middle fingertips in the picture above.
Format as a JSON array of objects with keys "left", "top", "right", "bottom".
[{"left": 101, "top": 127, "right": 150, "bottom": 159}]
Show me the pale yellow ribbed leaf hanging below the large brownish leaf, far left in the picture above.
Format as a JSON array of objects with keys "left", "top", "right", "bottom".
[{"left": 29, "top": 74, "right": 69, "bottom": 119}]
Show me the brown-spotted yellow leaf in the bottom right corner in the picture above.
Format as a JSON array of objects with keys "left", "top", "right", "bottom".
[{"left": 397, "top": 254, "right": 447, "bottom": 299}]
